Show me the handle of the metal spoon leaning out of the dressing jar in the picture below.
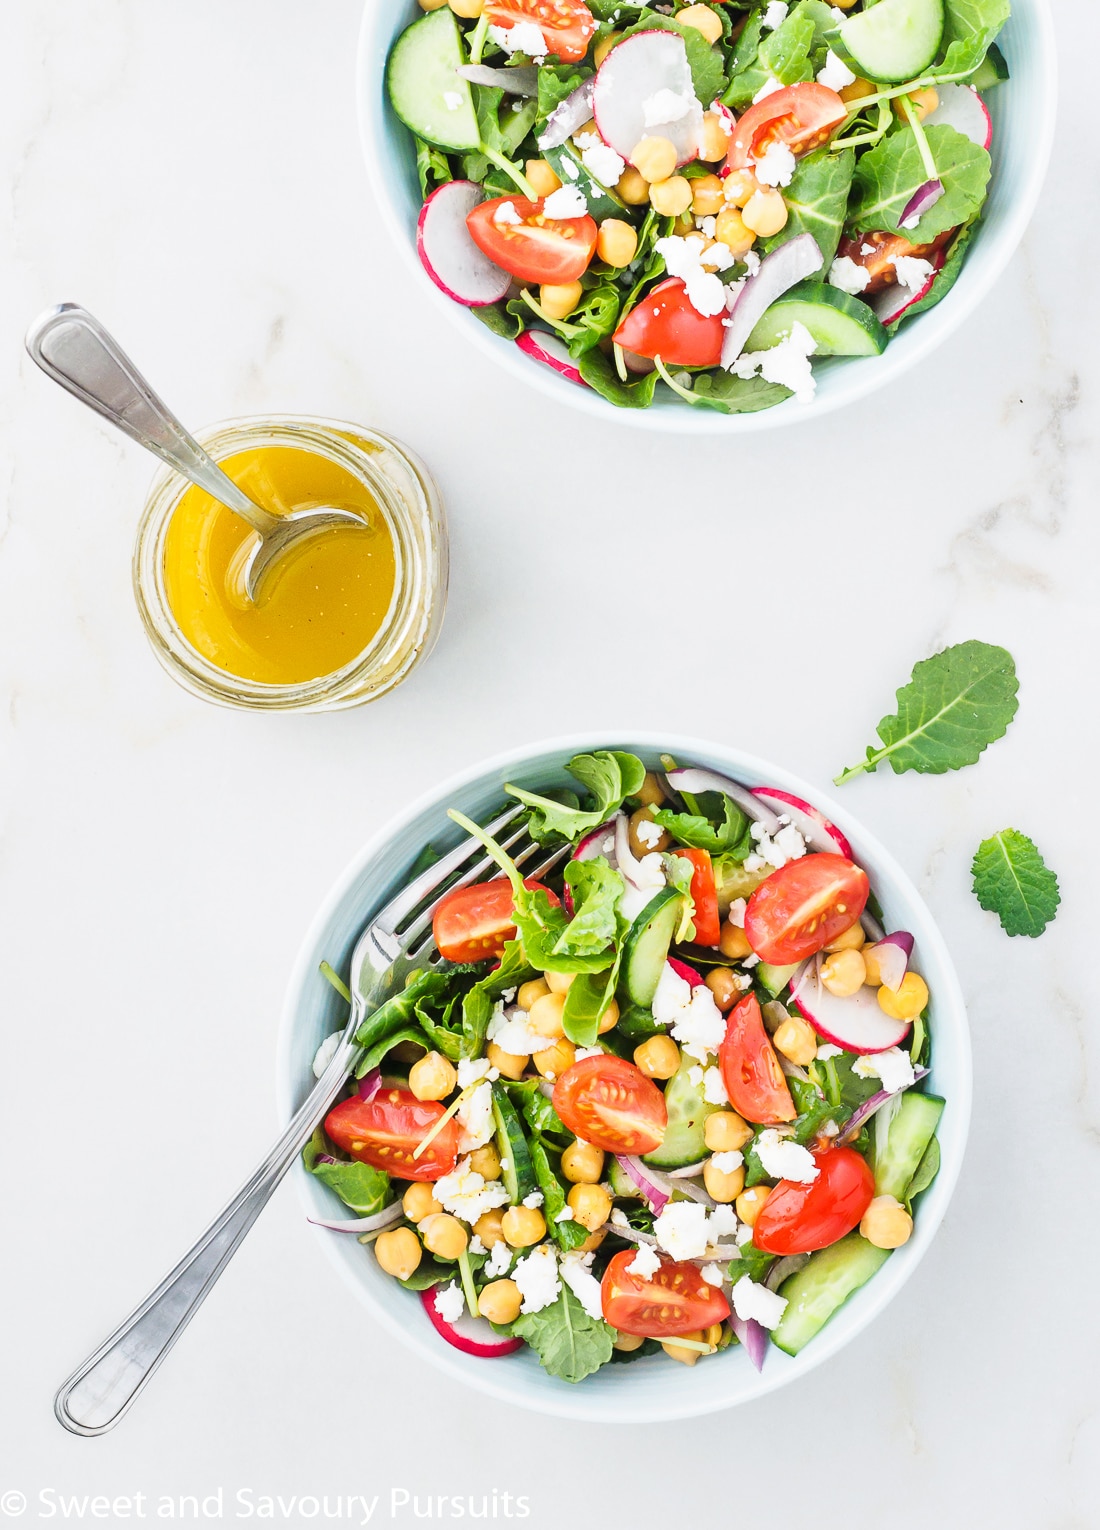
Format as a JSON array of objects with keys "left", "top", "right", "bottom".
[{"left": 26, "top": 303, "right": 278, "bottom": 536}]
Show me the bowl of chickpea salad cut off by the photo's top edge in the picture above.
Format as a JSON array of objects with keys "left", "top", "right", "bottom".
[{"left": 358, "top": 0, "right": 1056, "bottom": 431}]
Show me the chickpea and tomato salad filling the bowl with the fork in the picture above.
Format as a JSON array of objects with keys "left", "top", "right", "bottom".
[{"left": 304, "top": 750, "right": 944, "bottom": 1382}]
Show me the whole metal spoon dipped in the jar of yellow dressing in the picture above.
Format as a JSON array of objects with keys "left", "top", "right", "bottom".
[{"left": 26, "top": 303, "right": 367, "bottom": 601}]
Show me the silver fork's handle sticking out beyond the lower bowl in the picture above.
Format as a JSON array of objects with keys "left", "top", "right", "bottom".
[{"left": 54, "top": 1027, "right": 363, "bottom": 1435}]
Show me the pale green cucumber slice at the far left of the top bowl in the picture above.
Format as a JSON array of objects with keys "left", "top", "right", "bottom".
[{"left": 386, "top": 0, "right": 483, "bottom": 148}]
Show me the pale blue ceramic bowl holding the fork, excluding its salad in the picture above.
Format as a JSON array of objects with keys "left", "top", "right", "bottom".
[{"left": 278, "top": 733, "right": 971, "bottom": 1423}]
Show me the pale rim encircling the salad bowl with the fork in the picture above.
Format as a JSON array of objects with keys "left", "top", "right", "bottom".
[{"left": 275, "top": 728, "right": 973, "bottom": 1423}]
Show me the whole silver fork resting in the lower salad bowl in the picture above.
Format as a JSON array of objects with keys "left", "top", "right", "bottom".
[{"left": 54, "top": 806, "right": 568, "bottom": 1435}]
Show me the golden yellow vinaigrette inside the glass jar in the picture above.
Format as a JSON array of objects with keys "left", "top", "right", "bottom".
[{"left": 164, "top": 442, "right": 398, "bottom": 685}]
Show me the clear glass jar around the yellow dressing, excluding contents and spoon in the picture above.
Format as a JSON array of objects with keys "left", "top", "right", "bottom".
[{"left": 133, "top": 415, "right": 448, "bottom": 711}]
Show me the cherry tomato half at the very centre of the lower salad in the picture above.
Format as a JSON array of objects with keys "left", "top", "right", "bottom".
[{"left": 554, "top": 1054, "right": 669, "bottom": 1155}]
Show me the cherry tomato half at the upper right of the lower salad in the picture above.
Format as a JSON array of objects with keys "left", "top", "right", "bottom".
[{"left": 745, "top": 855, "right": 871, "bottom": 967}]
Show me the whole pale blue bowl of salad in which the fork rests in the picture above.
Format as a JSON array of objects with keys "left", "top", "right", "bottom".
[{"left": 278, "top": 734, "right": 971, "bottom": 1423}]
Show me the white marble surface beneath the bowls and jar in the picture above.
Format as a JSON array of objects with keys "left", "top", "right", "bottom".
[{"left": 0, "top": 0, "right": 1100, "bottom": 1530}]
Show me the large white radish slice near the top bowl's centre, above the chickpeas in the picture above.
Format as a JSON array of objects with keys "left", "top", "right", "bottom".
[{"left": 593, "top": 32, "right": 702, "bottom": 165}]
